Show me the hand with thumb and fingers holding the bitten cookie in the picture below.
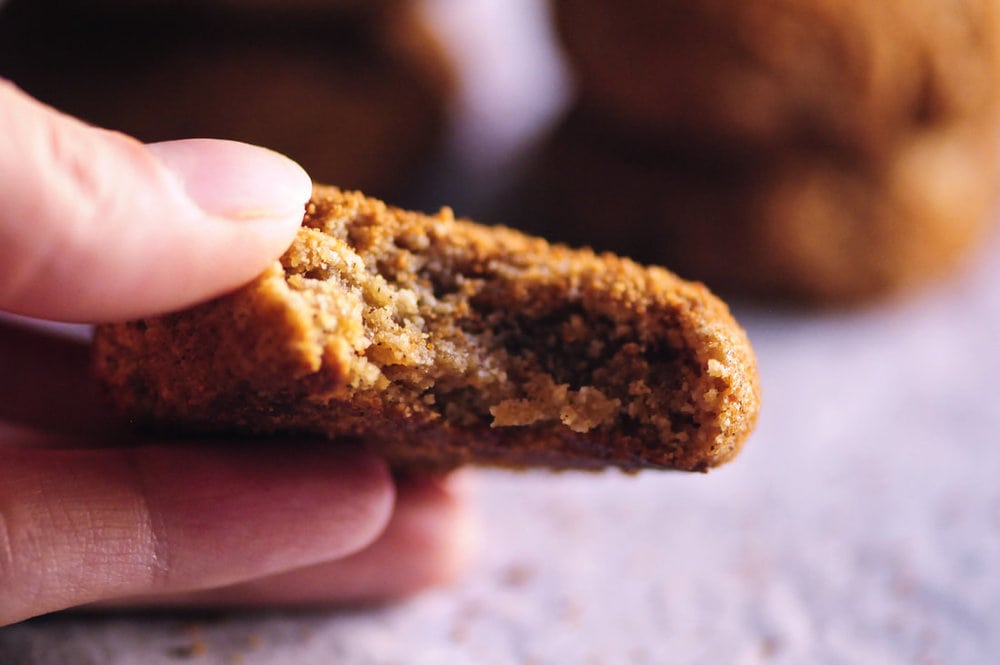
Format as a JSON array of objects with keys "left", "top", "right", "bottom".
[{"left": 0, "top": 80, "right": 467, "bottom": 625}]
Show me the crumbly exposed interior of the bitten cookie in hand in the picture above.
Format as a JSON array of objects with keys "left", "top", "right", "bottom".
[{"left": 281, "top": 189, "right": 744, "bottom": 454}]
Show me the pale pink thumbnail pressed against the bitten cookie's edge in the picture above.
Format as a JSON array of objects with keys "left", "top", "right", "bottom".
[{"left": 147, "top": 139, "right": 312, "bottom": 220}]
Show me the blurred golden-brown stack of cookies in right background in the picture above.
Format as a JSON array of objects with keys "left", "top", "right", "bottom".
[{"left": 530, "top": 0, "right": 1000, "bottom": 303}]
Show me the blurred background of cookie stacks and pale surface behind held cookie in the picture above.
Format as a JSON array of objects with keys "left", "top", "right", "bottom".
[{"left": 0, "top": 0, "right": 1000, "bottom": 665}]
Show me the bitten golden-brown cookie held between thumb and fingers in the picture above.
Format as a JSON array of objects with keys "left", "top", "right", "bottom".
[{"left": 94, "top": 187, "right": 759, "bottom": 471}]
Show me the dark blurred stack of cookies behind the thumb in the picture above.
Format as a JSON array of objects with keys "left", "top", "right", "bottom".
[{"left": 0, "top": 0, "right": 453, "bottom": 195}]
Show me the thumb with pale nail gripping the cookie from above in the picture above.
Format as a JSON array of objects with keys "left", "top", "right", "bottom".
[{"left": 0, "top": 79, "right": 311, "bottom": 321}]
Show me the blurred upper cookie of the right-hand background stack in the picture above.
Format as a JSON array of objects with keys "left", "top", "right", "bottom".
[{"left": 555, "top": 0, "right": 1000, "bottom": 154}]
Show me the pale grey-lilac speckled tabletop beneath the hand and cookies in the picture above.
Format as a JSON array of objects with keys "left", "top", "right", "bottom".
[{"left": 0, "top": 235, "right": 1000, "bottom": 665}]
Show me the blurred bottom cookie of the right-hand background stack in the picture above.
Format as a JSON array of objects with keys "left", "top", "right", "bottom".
[{"left": 515, "top": 108, "right": 998, "bottom": 304}]
